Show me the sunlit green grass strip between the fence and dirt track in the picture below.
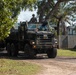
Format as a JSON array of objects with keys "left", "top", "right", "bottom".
[{"left": 57, "top": 49, "right": 76, "bottom": 57}]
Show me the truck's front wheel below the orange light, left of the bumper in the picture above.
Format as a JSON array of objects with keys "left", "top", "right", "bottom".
[{"left": 24, "top": 44, "right": 35, "bottom": 58}]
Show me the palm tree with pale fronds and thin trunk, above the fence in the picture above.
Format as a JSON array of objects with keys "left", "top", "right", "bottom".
[{"left": 54, "top": 2, "right": 76, "bottom": 35}]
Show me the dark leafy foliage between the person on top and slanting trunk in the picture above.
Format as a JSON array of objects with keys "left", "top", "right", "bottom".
[{"left": 36, "top": 0, "right": 55, "bottom": 22}]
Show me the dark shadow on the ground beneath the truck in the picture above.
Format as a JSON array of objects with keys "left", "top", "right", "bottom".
[{"left": 0, "top": 52, "right": 49, "bottom": 60}]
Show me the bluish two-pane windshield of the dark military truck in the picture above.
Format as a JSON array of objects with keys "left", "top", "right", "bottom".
[{"left": 28, "top": 24, "right": 48, "bottom": 31}]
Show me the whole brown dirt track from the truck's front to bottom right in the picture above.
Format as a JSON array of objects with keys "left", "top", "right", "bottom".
[{"left": 21, "top": 57, "right": 76, "bottom": 75}]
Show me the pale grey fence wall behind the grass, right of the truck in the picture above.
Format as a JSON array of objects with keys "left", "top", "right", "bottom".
[{"left": 59, "top": 35, "right": 76, "bottom": 48}]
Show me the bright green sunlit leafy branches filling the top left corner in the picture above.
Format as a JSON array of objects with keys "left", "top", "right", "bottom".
[{"left": 0, "top": 0, "right": 35, "bottom": 40}]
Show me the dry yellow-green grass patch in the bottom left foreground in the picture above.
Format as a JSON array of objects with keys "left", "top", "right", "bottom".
[{"left": 0, "top": 59, "right": 41, "bottom": 75}]
